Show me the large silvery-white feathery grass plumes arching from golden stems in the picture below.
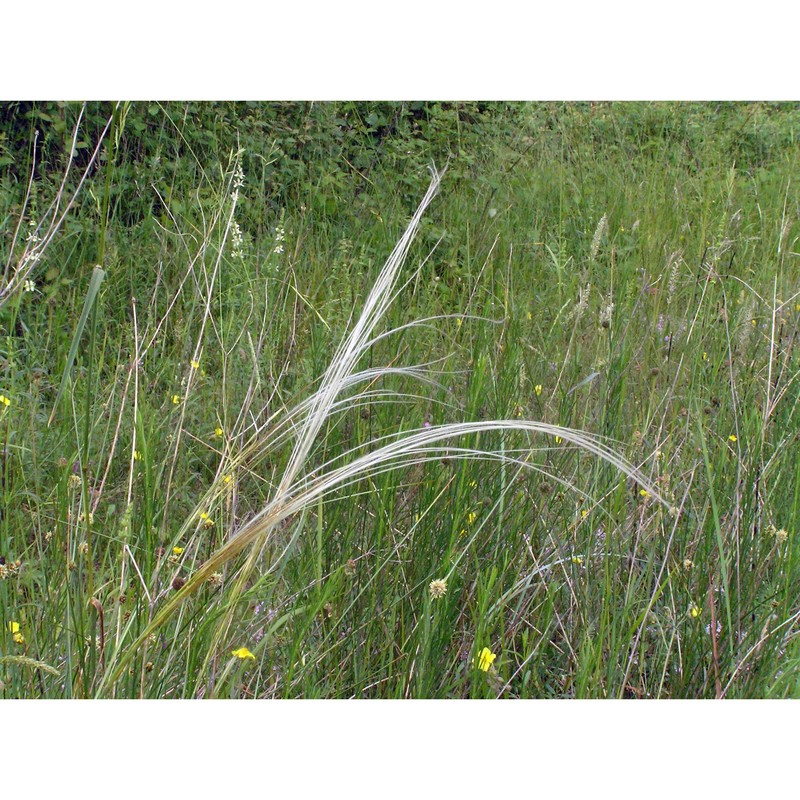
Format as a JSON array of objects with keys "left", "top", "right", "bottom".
[{"left": 100, "top": 169, "right": 668, "bottom": 694}]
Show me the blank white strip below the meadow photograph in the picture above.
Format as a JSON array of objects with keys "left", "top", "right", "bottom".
[{"left": 0, "top": 700, "right": 797, "bottom": 800}]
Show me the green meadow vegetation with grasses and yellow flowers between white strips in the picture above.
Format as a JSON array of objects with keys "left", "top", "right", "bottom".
[{"left": 0, "top": 103, "right": 800, "bottom": 698}]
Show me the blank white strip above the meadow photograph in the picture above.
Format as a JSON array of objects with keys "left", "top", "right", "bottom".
[{"left": 0, "top": 0, "right": 800, "bottom": 100}]
